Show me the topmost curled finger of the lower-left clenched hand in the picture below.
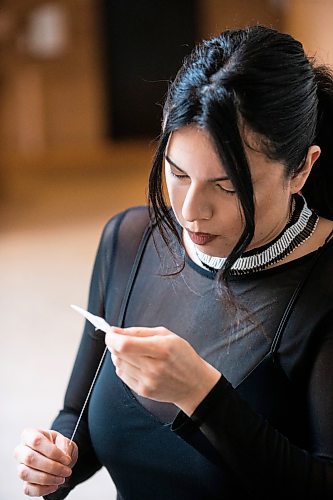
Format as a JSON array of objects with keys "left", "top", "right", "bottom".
[{"left": 22, "top": 429, "right": 71, "bottom": 465}]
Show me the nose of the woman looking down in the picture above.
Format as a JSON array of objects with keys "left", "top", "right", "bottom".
[{"left": 182, "top": 184, "right": 213, "bottom": 222}]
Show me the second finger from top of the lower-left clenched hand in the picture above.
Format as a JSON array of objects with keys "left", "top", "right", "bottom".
[{"left": 15, "top": 445, "right": 72, "bottom": 477}]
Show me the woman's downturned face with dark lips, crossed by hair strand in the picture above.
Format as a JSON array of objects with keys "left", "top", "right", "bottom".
[{"left": 165, "top": 125, "right": 294, "bottom": 257}]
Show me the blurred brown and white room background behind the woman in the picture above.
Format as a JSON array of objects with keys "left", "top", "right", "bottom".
[{"left": 0, "top": 0, "right": 333, "bottom": 500}]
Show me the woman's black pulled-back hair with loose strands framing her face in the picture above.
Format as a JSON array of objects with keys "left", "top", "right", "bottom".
[{"left": 148, "top": 26, "right": 333, "bottom": 279}]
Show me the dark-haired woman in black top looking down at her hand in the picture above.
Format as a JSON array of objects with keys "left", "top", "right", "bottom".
[{"left": 16, "top": 26, "right": 333, "bottom": 500}]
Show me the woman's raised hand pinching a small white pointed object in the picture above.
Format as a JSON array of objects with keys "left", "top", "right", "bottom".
[{"left": 105, "top": 327, "right": 221, "bottom": 416}]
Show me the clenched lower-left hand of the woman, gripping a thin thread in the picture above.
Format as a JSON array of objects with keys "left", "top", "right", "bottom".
[{"left": 15, "top": 429, "right": 78, "bottom": 497}]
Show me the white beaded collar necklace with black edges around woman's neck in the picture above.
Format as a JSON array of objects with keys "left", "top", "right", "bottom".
[{"left": 185, "top": 195, "right": 319, "bottom": 275}]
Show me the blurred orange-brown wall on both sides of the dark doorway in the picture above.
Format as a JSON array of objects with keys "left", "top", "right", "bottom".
[{"left": 0, "top": 0, "right": 333, "bottom": 163}]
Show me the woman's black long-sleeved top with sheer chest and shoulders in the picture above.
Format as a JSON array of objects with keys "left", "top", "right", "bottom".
[{"left": 47, "top": 208, "right": 333, "bottom": 500}]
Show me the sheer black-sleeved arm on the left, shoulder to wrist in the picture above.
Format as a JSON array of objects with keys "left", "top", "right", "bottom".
[{"left": 47, "top": 207, "right": 149, "bottom": 500}]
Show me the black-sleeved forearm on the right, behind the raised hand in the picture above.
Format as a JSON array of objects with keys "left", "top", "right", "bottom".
[{"left": 172, "top": 322, "right": 333, "bottom": 499}]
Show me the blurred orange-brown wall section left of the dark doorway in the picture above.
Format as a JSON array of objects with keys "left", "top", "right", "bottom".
[{"left": 0, "top": 0, "right": 103, "bottom": 153}]
